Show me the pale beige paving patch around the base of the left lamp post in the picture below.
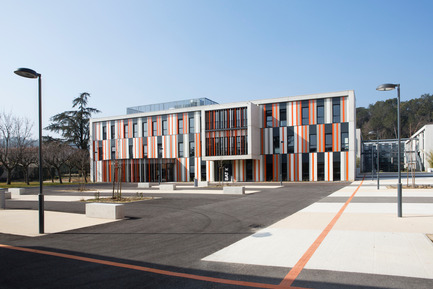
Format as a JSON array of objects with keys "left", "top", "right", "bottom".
[{"left": 0, "top": 210, "right": 115, "bottom": 237}]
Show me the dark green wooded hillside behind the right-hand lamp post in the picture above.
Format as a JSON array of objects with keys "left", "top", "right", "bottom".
[{"left": 356, "top": 94, "right": 433, "bottom": 139}]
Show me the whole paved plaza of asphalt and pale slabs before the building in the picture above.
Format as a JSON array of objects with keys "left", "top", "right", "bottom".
[{"left": 0, "top": 175, "right": 433, "bottom": 288}]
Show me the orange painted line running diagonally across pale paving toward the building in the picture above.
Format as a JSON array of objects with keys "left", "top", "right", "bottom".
[{"left": 280, "top": 176, "right": 365, "bottom": 288}]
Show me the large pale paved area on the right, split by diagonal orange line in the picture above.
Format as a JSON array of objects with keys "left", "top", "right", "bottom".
[{"left": 203, "top": 176, "right": 433, "bottom": 279}]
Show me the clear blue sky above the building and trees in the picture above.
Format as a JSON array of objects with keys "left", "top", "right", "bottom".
[{"left": 0, "top": 0, "right": 433, "bottom": 136}]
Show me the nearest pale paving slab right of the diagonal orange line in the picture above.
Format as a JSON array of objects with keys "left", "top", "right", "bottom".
[{"left": 305, "top": 230, "right": 433, "bottom": 279}]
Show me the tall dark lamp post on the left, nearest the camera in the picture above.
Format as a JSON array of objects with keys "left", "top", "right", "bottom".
[{"left": 14, "top": 68, "right": 45, "bottom": 234}]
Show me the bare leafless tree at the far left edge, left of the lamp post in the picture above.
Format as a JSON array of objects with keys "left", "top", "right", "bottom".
[{"left": 0, "top": 112, "right": 33, "bottom": 184}]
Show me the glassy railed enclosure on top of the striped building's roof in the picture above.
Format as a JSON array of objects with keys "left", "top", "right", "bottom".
[{"left": 126, "top": 97, "right": 218, "bottom": 114}]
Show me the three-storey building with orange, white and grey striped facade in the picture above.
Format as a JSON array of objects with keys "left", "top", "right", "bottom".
[{"left": 90, "top": 91, "right": 356, "bottom": 182}]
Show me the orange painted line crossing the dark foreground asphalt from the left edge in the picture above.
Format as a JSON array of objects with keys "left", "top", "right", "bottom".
[{"left": 0, "top": 244, "right": 305, "bottom": 289}]
